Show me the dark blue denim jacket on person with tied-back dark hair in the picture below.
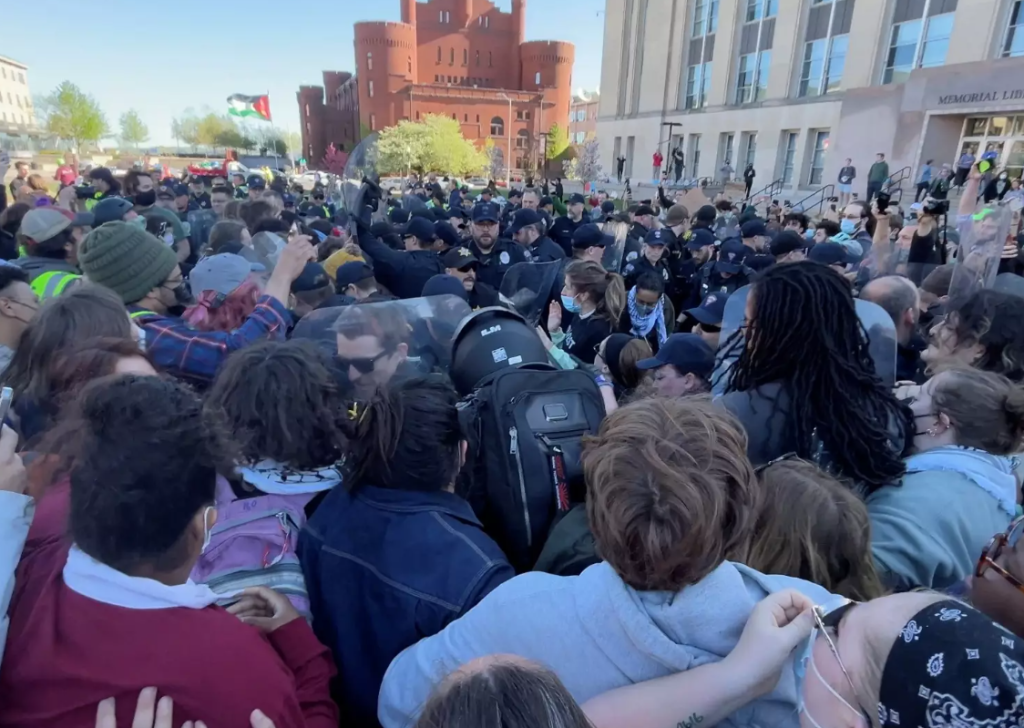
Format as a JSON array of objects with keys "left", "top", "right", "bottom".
[{"left": 299, "top": 485, "right": 514, "bottom": 726}]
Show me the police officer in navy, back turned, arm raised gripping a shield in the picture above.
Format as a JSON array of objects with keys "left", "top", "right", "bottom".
[{"left": 356, "top": 213, "right": 444, "bottom": 298}]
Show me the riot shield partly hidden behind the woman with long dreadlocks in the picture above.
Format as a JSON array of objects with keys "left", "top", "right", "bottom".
[{"left": 711, "top": 286, "right": 896, "bottom": 396}]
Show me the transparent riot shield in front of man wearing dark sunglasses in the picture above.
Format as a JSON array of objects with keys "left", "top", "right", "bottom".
[{"left": 292, "top": 295, "right": 472, "bottom": 400}]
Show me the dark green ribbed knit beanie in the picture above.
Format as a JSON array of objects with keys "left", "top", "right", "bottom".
[{"left": 78, "top": 220, "right": 178, "bottom": 303}]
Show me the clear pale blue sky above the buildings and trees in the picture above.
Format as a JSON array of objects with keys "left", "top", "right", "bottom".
[{"left": 0, "top": 0, "right": 604, "bottom": 144}]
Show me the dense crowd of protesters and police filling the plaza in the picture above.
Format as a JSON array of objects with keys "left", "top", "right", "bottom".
[{"left": 0, "top": 155, "right": 1024, "bottom": 728}]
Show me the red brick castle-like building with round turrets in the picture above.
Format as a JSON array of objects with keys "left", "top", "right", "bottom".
[{"left": 299, "top": 0, "right": 575, "bottom": 170}]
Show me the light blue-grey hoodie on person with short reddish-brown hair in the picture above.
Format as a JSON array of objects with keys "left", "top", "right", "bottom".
[{"left": 377, "top": 562, "right": 830, "bottom": 728}]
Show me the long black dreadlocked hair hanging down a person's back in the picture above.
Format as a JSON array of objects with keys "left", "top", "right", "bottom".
[{"left": 725, "top": 261, "right": 907, "bottom": 491}]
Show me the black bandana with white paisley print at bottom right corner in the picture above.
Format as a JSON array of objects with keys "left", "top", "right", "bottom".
[{"left": 879, "top": 600, "right": 1024, "bottom": 728}]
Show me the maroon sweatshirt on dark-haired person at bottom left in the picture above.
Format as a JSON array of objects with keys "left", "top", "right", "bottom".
[{"left": 0, "top": 488, "right": 338, "bottom": 728}]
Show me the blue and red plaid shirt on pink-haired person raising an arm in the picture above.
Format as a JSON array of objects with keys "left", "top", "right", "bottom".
[{"left": 128, "top": 296, "right": 291, "bottom": 383}]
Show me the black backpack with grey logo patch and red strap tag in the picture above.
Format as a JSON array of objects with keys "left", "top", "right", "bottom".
[{"left": 460, "top": 365, "right": 604, "bottom": 572}]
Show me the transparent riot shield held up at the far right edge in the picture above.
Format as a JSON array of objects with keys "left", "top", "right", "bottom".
[{"left": 946, "top": 207, "right": 1013, "bottom": 310}]
